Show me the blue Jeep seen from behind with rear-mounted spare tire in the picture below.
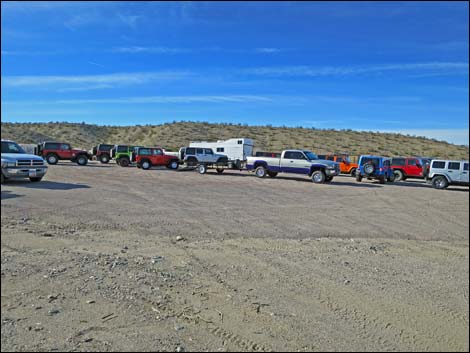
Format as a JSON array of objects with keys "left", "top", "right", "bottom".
[{"left": 356, "top": 156, "right": 395, "bottom": 184}]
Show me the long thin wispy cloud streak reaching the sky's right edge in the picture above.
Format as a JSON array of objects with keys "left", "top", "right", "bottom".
[{"left": 241, "top": 62, "right": 469, "bottom": 77}]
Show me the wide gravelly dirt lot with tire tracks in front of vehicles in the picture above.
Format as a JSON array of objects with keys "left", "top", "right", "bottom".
[{"left": 1, "top": 162, "right": 469, "bottom": 351}]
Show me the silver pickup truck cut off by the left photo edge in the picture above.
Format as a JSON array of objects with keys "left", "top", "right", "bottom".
[{"left": 1, "top": 140, "right": 47, "bottom": 184}]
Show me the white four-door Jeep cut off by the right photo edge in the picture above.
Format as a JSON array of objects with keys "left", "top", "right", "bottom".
[{"left": 427, "top": 159, "right": 469, "bottom": 189}]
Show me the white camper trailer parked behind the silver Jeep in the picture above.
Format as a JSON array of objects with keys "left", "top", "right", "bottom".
[{"left": 189, "top": 138, "right": 253, "bottom": 169}]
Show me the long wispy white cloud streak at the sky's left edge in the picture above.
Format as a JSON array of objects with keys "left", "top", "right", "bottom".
[{"left": 2, "top": 71, "right": 191, "bottom": 87}]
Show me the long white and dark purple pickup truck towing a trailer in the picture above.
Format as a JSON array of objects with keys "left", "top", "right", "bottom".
[{"left": 246, "top": 150, "right": 340, "bottom": 184}]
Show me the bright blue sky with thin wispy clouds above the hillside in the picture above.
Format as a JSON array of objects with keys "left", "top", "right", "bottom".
[{"left": 1, "top": 1, "right": 469, "bottom": 145}]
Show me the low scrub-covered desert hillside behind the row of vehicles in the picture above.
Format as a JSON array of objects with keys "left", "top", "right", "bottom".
[{"left": 1, "top": 122, "right": 469, "bottom": 159}]
